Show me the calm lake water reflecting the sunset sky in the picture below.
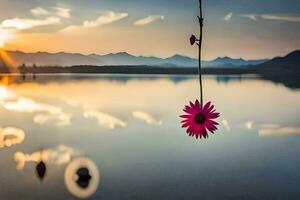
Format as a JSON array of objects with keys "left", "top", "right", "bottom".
[{"left": 0, "top": 75, "right": 300, "bottom": 200}]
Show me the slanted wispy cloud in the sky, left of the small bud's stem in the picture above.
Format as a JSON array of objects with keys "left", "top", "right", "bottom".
[{"left": 83, "top": 11, "right": 128, "bottom": 28}]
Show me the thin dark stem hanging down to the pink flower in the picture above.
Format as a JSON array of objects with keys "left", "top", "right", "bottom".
[{"left": 198, "top": 0, "right": 204, "bottom": 106}]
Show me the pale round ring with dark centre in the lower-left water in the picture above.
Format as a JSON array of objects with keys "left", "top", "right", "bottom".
[{"left": 65, "top": 157, "right": 100, "bottom": 199}]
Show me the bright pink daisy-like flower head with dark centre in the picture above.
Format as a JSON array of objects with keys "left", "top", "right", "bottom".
[{"left": 180, "top": 100, "right": 220, "bottom": 139}]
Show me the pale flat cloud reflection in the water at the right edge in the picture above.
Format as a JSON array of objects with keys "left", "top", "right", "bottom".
[{"left": 258, "top": 127, "right": 300, "bottom": 136}]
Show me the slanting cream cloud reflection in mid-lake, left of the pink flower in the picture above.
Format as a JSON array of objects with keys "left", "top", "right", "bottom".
[{"left": 84, "top": 110, "right": 127, "bottom": 129}]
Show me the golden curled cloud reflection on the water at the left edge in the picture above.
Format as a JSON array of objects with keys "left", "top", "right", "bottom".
[{"left": 0, "top": 127, "right": 25, "bottom": 148}]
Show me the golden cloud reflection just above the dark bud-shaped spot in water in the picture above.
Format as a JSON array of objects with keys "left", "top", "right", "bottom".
[{"left": 14, "top": 145, "right": 82, "bottom": 170}]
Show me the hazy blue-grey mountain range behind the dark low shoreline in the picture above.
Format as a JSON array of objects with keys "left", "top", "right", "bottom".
[{"left": 0, "top": 51, "right": 268, "bottom": 68}]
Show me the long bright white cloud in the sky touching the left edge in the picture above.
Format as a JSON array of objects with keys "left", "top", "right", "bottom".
[{"left": 1, "top": 17, "right": 61, "bottom": 30}]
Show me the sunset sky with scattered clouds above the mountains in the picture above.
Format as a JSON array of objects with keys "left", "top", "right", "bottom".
[{"left": 0, "top": 0, "right": 300, "bottom": 60}]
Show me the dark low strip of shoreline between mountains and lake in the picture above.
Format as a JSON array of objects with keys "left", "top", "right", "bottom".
[{"left": 0, "top": 65, "right": 300, "bottom": 76}]
